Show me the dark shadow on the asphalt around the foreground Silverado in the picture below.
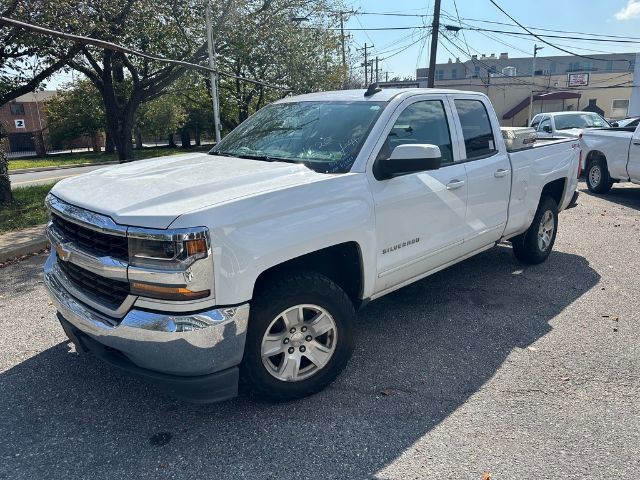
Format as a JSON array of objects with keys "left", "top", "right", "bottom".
[{"left": 0, "top": 246, "right": 600, "bottom": 479}]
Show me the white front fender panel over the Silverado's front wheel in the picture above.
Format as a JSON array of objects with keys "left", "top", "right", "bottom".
[{"left": 172, "top": 173, "right": 376, "bottom": 305}]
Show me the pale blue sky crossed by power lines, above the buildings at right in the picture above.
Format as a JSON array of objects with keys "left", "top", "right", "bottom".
[{"left": 346, "top": 0, "right": 640, "bottom": 77}]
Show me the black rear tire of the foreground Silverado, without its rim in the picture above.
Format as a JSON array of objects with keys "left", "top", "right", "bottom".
[{"left": 511, "top": 197, "right": 558, "bottom": 265}]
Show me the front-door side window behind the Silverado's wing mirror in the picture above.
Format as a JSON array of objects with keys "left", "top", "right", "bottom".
[{"left": 378, "top": 100, "right": 453, "bottom": 165}]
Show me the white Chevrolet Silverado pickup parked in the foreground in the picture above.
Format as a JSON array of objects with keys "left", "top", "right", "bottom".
[{"left": 44, "top": 86, "right": 579, "bottom": 402}]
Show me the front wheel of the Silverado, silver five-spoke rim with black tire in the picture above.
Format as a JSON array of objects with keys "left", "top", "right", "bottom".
[{"left": 241, "top": 272, "right": 355, "bottom": 401}]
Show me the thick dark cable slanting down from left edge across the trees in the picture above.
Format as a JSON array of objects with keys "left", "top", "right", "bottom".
[{"left": 0, "top": 17, "right": 291, "bottom": 91}]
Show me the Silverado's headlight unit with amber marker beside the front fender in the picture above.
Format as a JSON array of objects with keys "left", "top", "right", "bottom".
[{"left": 127, "top": 227, "right": 213, "bottom": 300}]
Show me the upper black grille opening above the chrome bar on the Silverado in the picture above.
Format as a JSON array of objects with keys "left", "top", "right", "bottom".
[{"left": 51, "top": 213, "right": 129, "bottom": 261}]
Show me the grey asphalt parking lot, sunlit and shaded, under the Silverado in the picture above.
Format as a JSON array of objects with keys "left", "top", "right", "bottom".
[{"left": 0, "top": 183, "right": 640, "bottom": 479}]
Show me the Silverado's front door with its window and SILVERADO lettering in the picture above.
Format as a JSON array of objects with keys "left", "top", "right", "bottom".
[{"left": 369, "top": 95, "right": 467, "bottom": 294}]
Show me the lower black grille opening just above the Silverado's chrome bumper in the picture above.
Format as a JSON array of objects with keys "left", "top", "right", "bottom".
[{"left": 58, "top": 260, "right": 129, "bottom": 310}]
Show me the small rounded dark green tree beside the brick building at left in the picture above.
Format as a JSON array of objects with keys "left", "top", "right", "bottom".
[{"left": 45, "top": 80, "right": 106, "bottom": 151}]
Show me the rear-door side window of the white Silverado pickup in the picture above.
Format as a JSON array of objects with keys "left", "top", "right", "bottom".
[{"left": 455, "top": 100, "right": 497, "bottom": 160}]
